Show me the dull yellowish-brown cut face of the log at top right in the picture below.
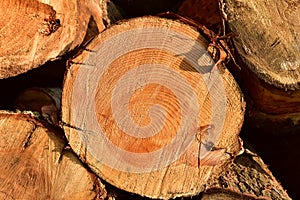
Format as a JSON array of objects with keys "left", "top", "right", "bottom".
[{"left": 226, "top": 0, "right": 300, "bottom": 90}]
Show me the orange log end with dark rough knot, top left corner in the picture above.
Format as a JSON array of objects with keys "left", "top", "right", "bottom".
[{"left": 0, "top": 0, "right": 105, "bottom": 79}]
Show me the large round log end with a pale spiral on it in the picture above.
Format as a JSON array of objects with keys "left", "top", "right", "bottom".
[{"left": 62, "top": 17, "right": 245, "bottom": 198}]
